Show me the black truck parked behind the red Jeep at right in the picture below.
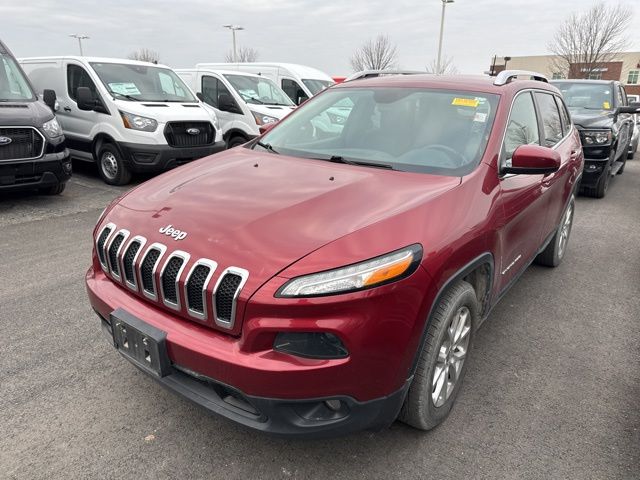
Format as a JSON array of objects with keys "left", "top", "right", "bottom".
[{"left": 552, "top": 80, "right": 635, "bottom": 198}]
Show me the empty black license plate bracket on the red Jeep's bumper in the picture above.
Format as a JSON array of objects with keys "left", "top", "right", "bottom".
[{"left": 109, "top": 308, "right": 171, "bottom": 378}]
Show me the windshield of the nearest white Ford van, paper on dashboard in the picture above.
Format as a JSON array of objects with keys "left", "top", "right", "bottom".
[{"left": 91, "top": 63, "right": 197, "bottom": 103}]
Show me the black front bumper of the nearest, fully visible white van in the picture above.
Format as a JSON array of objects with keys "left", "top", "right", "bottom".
[{"left": 118, "top": 141, "right": 226, "bottom": 173}]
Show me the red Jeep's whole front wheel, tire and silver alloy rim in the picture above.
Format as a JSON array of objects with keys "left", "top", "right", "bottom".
[{"left": 399, "top": 281, "right": 478, "bottom": 430}]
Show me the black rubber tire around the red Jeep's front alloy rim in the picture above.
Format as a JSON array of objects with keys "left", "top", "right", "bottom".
[{"left": 398, "top": 281, "right": 478, "bottom": 430}]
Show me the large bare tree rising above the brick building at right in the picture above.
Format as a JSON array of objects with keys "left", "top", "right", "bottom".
[{"left": 548, "top": 2, "right": 632, "bottom": 78}]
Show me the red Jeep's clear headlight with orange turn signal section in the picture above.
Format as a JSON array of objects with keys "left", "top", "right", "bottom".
[{"left": 276, "top": 245, "right": 422, "bottom": 297}]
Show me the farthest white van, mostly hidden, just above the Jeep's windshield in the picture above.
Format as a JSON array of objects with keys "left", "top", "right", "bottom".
[{"left": 196, "top": 62, "right": 334, "bottom": 105}]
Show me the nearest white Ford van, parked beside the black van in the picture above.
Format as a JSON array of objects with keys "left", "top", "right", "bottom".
[{"left": 20, "top": 56, "right": 225, "bottom": 185}]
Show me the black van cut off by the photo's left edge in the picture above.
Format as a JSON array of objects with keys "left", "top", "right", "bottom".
[{"left": 0, "top": 41, "right": 71, "bottom": 195}]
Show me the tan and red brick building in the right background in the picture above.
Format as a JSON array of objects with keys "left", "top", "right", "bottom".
[{"left": 489, "top": 52, "right": 640, "bottom": 95}]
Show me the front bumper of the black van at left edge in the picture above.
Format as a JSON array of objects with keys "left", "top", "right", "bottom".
[{"left": 0, "top": 149, "right": 72, "bottom": 192}]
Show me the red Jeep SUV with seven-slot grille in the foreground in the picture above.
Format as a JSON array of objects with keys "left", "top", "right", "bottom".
[{"left": 86, "top": 71, "right": 584, "bottom": 436}]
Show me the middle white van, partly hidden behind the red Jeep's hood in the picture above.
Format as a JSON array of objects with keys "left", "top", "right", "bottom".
[{"left": 175, "top": 68, "right": 295, "bottom": 148}]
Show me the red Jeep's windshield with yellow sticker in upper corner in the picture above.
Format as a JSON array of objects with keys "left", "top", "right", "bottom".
[{"left": 254, "top": 87, "right": 498, "bottom": 176}]
